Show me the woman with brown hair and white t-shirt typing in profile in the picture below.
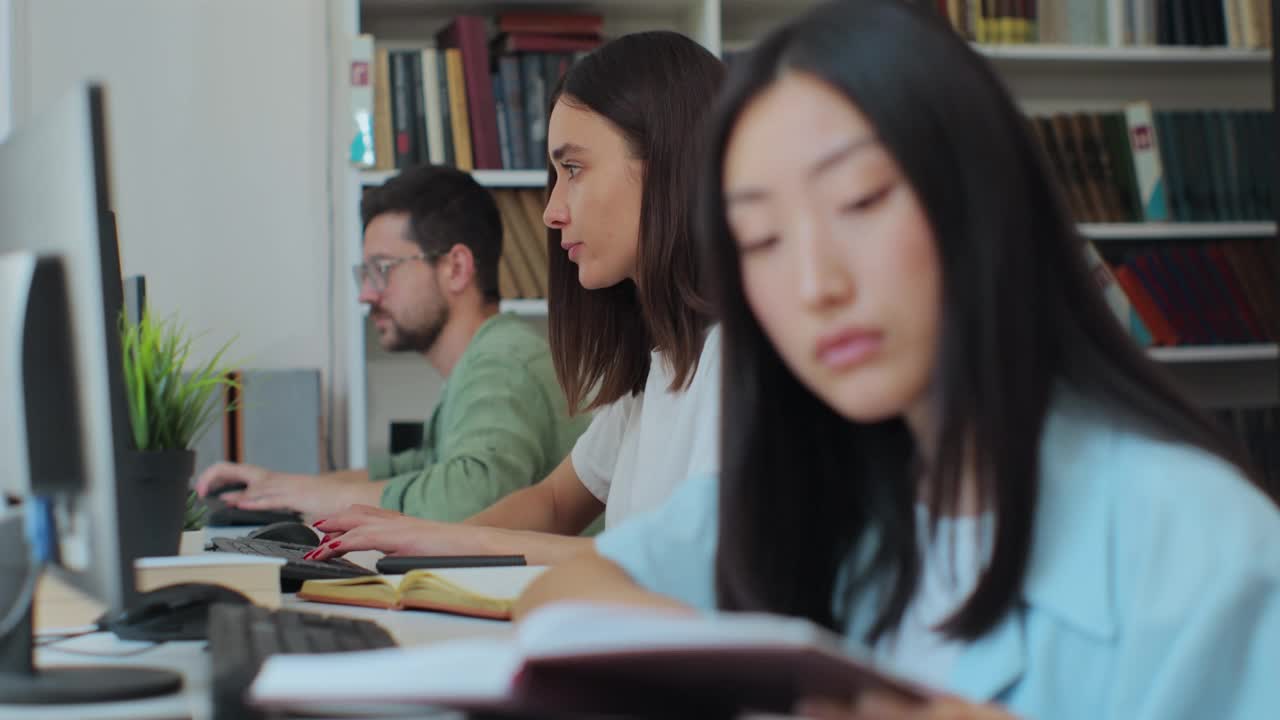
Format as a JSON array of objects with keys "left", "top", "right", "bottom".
[{"left": 314, "top": 32, "right": 723, "bottom": 564}]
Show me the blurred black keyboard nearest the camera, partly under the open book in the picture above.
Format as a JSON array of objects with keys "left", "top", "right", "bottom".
[{"left": 209, "top": 603, "right": 396, "bottom": 720}]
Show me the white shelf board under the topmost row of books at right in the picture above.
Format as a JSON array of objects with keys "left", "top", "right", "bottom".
[{"left": 974, "top": 45, "right": 1271, "bottom": 65}]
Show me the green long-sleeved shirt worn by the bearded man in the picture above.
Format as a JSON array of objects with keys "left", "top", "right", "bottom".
[{"left": 369, "top": 314, "right": 590, "bottom": 521}]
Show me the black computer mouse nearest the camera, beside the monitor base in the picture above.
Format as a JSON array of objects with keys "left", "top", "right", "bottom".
[{"left": 97, "top": 583, "right": 251, "bottom": 642}]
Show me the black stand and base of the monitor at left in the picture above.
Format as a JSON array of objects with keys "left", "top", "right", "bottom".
[{"left": 0, "top": 515, "right": 182, "bottom": 705}]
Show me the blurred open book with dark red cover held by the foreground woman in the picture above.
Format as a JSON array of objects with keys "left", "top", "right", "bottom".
[{"left": 250, "top": 605, "right": 931, "bottom": 716}]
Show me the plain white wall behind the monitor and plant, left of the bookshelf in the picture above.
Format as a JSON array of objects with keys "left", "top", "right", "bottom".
[{"left": 16, "top": 0, "right": 351, "bottom": 461}]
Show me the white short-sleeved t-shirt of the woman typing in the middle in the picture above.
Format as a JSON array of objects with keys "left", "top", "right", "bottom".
[{"left": 570, "top": 327, "right": 719, "bottom": 528}]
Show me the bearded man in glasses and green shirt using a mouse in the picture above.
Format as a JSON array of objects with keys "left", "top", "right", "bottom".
[{"left": 196, "top": 165, "right": 589, "bottom": 521}]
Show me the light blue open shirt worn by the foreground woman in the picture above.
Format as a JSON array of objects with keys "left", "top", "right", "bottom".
[{"left": 596, "top": 392, "right": 1280, "bottom": 720}]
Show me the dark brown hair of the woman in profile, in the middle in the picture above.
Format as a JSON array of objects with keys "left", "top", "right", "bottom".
[{"left": 547, "top": 32, "right": 724, "bottom": 411}]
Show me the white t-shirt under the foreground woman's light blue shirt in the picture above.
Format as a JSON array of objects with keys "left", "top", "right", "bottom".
[{"left": 876, "top": 505, "right": 992, "bottom": 688}]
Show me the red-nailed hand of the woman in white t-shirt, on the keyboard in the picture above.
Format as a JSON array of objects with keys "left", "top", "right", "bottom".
[{"left": 306, "top": 505, "right": 503, "bottom": 560}]
